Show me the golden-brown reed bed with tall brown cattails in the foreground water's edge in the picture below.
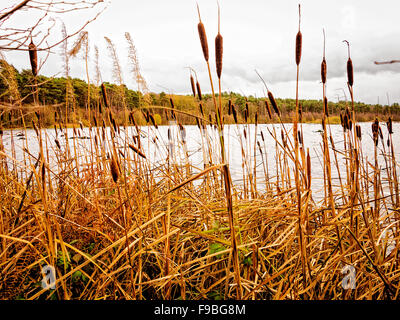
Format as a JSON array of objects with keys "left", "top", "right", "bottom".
[{"left": 0, "top": 3, "right": 400, "bottom": 300}]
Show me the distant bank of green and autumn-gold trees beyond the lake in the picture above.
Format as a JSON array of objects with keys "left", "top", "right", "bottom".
[{"left": 0, "top": 60, "right": 400, "bottom": 126}]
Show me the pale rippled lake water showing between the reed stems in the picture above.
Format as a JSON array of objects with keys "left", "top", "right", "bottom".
[{"left": 3, "top": 123, "right": 400, "bottom": 199}]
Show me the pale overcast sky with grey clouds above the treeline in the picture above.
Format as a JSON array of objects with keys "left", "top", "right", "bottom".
[{"left": 2, "top": 0, "right": 400, "bottom": 104}]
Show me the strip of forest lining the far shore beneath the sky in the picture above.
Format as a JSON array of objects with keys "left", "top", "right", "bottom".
[{"left": 0, "top": 60, "right": 400, "bottom": 128}]
